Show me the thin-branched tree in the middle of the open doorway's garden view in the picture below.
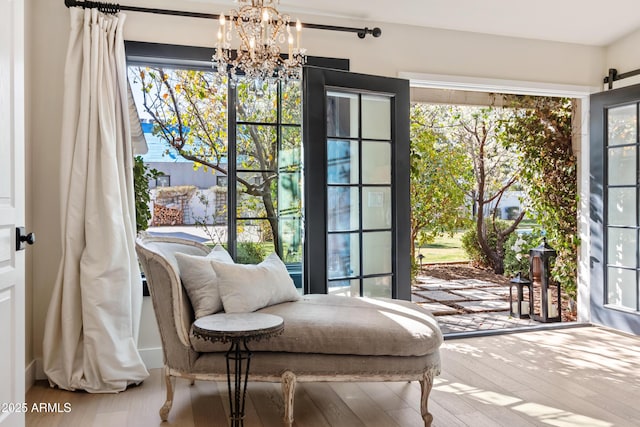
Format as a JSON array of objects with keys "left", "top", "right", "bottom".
[{"left": 450, "top": 107, "right": 526, "bottom": 274}]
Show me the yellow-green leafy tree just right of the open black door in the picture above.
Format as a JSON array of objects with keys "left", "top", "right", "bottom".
[{"left": 410, "top": 104, "right": 471, "bottom": 260}]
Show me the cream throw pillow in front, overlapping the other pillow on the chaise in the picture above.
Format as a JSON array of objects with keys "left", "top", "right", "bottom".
[{"left": 211, "top": 253, "right": 300, "bottom": 313}]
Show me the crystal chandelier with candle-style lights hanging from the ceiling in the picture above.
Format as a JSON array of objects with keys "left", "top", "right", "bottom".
[{"left": 212, "top": 0, "right": 306, "bottom": 82}]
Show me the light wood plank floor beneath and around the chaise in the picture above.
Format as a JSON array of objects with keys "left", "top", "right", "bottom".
[{"left": 26, "top": 327, "right": 640, "bottom": 427}]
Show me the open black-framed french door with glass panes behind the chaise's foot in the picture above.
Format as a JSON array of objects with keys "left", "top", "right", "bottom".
[{"left": 303, "top": 67, "right": 411, "bottom": 299}]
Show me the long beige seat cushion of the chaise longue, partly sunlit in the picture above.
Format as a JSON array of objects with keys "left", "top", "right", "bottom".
[{"left": 190, "top": 295, "right": 442, "bottom": 356}]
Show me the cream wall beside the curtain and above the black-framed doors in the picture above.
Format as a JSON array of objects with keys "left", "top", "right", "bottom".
[{"left": 26, "top": 0, "right": 612, "bottom": 372}]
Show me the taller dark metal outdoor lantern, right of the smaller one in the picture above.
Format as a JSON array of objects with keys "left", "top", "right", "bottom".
[{"left": 529, "top": 238, "right": 562, "bottom": 323}]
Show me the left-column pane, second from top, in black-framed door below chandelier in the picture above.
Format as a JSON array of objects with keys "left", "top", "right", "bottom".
[{"left": 236, "top": 125, "right": 278, "bottom": 170}]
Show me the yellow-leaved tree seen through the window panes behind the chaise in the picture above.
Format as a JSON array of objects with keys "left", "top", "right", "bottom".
[{"left": 132, "top": 67, "right": 300, "bottom": 254}]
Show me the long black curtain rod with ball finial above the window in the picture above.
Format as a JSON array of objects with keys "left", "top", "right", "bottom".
[{"left": 64, "top": 0, "right": 382, "bottom": 39}]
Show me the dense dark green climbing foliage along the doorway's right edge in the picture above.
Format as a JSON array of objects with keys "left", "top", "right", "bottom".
[{"left": 502, "top": 97, "right": 580, "bottom": 298}]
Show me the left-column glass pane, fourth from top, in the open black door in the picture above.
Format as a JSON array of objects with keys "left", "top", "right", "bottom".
[{"left": 327, "top": 233, "right": 360, "bottom": 279}]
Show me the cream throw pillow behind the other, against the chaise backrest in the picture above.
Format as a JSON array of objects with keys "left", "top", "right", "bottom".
[{"left": 176, "top": 245, "right": 233, "bottom": 319}]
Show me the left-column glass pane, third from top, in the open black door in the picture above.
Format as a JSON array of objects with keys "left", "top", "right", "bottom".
[{"left": 327, "top": 187, "right": 360, "bottom": 231}]
